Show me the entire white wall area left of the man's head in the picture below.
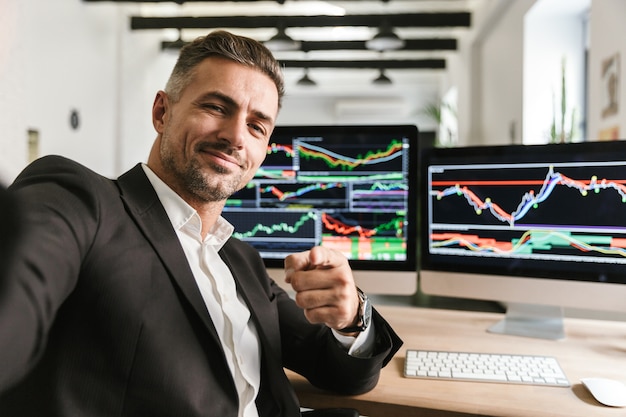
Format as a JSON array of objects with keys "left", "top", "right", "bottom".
[{"left": 0, "top": 0, "right": 195, "bottom": 183}]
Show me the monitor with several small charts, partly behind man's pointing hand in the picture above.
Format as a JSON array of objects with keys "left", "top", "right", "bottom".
[{"left": 223, "top": 125, "right": 418, "bottom": 294}]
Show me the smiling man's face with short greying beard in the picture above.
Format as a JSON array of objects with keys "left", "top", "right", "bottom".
[{"left": 150, "top": 57, "right": 278, "bottom": 203}]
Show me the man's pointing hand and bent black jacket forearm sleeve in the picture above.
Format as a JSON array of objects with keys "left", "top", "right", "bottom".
[{"left": 281, "top": 247, "right": 402, "bottom": 394}]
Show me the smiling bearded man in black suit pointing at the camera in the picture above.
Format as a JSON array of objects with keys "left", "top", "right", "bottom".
[{"left": 0, "top": 31, "right": 401, "bottom": 417}]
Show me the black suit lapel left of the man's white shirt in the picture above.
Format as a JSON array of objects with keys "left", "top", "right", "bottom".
[{"left": 118, "top": 164, "right": 221, "bottom": 346}]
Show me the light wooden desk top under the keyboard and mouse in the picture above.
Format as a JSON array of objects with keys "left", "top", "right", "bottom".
[{"left": 289, "top": 306, "right": 626, "bottom": 417}]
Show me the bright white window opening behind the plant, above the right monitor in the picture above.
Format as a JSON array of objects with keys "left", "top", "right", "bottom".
[{"left": 522, "top": 0, "right": 590, "bottom": 144}]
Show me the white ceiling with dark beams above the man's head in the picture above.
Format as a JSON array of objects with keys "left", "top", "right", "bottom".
[{"left": 82, "top": 0, "right": 489, "bottom": 112}]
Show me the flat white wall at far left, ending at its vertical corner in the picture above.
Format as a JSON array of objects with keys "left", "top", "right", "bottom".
[{"left": 0, "top": 0, "right": 118, "bottom": 182}]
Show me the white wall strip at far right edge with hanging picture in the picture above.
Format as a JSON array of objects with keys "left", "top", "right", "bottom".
[{"left": 588, "top": 0, "right": 626, "bottom": 139}]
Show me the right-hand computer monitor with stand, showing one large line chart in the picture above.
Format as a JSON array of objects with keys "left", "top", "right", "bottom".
[{"left": 419, "top": 141, "right": 626, "bottom": 339}]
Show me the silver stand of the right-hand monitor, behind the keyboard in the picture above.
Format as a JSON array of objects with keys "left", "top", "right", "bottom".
[{"left": 487, "top": 303, "right": 565, "bottom": 340}]
